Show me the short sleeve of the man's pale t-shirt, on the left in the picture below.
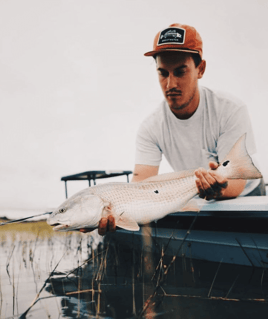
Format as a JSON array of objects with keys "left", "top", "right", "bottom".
[{"left": 135, "top": 122, "right": 162, "bottom": 166}]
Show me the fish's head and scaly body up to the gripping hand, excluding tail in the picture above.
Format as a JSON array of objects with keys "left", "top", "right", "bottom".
[{"left": 48, "top": 171, "right": 197, "bottom": 231}]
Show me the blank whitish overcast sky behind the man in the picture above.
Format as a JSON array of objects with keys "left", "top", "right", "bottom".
[{"left": 0, "top": 0, "right": 268, "bottom": 215}]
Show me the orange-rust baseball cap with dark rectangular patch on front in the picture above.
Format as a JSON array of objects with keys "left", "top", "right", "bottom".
[{"left": 144, "top": 23, "right": 203, "bottom": 58}]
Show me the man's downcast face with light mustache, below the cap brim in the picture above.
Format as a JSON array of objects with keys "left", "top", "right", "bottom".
[{"left": 156, "top": 51, "right": 205, "bottom": 118}]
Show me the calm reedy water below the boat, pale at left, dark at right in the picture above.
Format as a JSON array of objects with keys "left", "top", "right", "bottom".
[{"left": 0, "top": 222, "right": 268, "bottom": 319}]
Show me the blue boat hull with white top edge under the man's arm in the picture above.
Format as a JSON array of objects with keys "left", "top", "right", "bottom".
[{"left": 109, "top": 196, "right": 268, "bottom": 268}]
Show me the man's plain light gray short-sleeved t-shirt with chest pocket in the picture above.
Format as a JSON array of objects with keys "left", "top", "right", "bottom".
[{"left": 135, "top": 87, "right": 259, "bottom": 195}]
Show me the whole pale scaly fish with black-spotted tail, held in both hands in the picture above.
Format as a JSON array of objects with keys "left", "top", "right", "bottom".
[{"left": 47, "top": 134, "right": 262, "bottom": 231}]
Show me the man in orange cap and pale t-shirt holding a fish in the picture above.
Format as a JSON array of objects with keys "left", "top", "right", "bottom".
[{"left": 80, "top": 24, "right": 265, "bottom": 235}]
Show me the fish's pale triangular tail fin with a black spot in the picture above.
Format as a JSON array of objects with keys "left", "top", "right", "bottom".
[{"left": 217, "top": 133, "right": 262, "bottom": 179}]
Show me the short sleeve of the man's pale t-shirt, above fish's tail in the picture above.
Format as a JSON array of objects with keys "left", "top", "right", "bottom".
[{"left": 217, "top": 105, "right": 256, "bottom": 162}]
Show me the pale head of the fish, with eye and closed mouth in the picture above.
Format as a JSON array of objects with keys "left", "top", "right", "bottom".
[{"left": 47, "top": 193, "right": 104, "bottom": 231}]
